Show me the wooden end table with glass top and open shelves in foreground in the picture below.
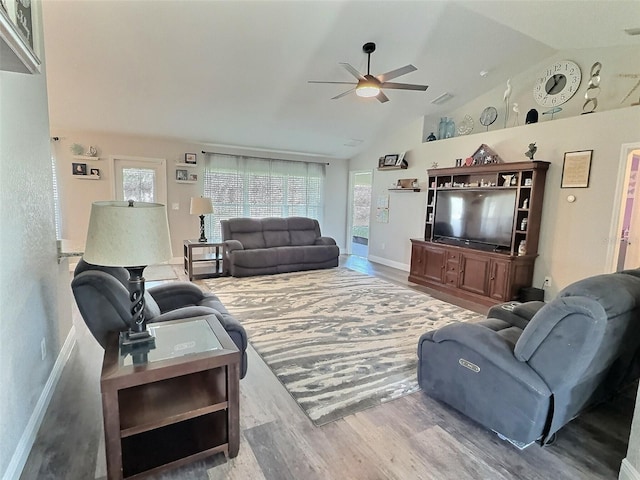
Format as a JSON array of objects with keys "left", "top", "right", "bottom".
[{"left": 100, "top": 315, "right": 240, "bottom": 480}]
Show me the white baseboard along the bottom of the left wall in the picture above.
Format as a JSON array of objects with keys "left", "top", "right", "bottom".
[{"left": 2, "top": 325, "right": 76, "bottom": 480}]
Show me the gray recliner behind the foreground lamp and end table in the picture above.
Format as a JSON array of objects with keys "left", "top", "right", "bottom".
[{"left": 71, "top": 260, "right": 247, "bottom": 378}]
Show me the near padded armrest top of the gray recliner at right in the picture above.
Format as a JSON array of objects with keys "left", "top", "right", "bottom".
[{"left": 428, "top": 323, "right": 551, "bottom": 395}]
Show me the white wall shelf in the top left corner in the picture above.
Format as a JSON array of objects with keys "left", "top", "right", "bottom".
[{"left": 0, "top": 7, "right": 40, "bottom": 74}]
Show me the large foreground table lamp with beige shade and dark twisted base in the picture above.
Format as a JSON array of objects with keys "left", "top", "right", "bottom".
[{"left": 83, "top": 200, "right": 171, "bottom": 346}]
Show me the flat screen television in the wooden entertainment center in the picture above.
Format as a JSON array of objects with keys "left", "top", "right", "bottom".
[{"left": 433, "top": 189, "right": 516, "bottom": 248}]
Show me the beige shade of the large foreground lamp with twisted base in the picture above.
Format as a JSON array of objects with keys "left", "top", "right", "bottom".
[{"left": 84, "top": 201, "right": 172, "bottom": 267}]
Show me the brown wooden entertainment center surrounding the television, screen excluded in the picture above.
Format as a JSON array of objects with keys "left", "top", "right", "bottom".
[{"left": 409, "top": 161, "right": 549, "bottom": 305}]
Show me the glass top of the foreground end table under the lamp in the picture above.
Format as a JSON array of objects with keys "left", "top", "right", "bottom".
[{"left": 120, "top": 318, "right": 222, "bottom": 366}]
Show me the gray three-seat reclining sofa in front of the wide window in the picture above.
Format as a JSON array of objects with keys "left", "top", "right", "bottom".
[{"left": 220, "top": 217, "right": 340, "bottom": 277}]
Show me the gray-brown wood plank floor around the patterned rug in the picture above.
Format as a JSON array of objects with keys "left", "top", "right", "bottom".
[{"left": 20, "top": 257, "right": 636, "bottom": 480}]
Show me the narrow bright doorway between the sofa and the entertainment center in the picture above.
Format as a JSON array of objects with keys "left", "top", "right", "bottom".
[{"left": 347, "top": 170, "right": 373, "bottom": 258}]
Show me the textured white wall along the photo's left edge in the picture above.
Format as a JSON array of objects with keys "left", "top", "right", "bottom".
[{"left": 0, "top": 2, "right": 71, "bottom": 478}]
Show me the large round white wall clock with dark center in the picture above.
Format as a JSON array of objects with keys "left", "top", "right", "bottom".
[{"left": 533, "top": 60, "right": 582, "bottom": 107}]
